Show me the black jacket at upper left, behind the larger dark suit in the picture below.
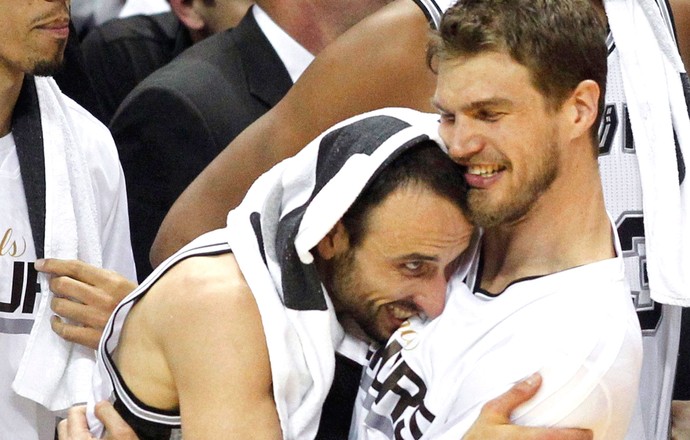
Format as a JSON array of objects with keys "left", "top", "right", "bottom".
[{"left": 81, "top": 12, "right": 192, "bottom": 125}]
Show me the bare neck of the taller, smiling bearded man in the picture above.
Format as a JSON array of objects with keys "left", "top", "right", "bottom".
[{"left": 481, "top": 147, "right": 615, "bottom": 293}]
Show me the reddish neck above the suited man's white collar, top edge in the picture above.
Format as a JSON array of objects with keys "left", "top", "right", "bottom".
[{"left": 257, "top": 0, "right": 388, "bottom": 55}]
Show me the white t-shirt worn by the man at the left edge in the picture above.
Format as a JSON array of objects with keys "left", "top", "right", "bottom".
[{"left": 0, "top": 91, "right": 136, "bottom": 440}]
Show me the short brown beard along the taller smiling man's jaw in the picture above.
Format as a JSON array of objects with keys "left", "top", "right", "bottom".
[{"left": 463, "top": 143, "right": 559, "bottom": 229}]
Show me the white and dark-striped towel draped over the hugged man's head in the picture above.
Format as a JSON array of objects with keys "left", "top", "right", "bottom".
[{"left": 227, "top": 108, "right": 441, "bottom": 440}]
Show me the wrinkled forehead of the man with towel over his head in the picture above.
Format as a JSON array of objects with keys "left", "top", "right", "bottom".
[{"left": 362, "top": 184, "right": 472, "bottom": 256}]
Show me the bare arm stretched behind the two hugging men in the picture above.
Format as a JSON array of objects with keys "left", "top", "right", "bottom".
[{"left": 151, "top": 0, "right": 435, "bottom": 267}]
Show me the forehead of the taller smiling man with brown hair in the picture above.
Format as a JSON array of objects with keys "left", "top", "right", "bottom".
[{"left": 434, "top": 52, "right": 538, "bottom": 108}]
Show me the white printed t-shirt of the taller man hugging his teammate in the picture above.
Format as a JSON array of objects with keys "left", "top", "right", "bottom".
[{"left": 350, "top": 225, "right": 642, "bottom": 440}]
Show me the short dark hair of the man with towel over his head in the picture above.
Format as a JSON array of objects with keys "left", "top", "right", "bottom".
[{"left": 341, "top": 140, "right": 466, "bottom": 248}]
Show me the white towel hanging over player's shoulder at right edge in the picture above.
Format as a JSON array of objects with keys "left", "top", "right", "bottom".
[{"left": 604, "top": 0, "right": 690, "bottom": 306}]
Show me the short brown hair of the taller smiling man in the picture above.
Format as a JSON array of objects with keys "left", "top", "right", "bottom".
[{"left": 427, "top": 0, "right": 608, "bottom": 150}]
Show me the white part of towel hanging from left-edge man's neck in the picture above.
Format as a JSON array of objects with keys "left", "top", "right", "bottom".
[{"left": 12, "top": 78, "right": 102, "bottom": 411}]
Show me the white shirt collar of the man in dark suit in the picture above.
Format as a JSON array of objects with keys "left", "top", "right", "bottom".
[{"left": 252, "top": 5, "right": 314, "bottom": 83}]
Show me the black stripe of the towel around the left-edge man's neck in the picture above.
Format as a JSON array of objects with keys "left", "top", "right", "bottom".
[{"left": 12, "top": 75, "right": 46, "bottom": 258}]
